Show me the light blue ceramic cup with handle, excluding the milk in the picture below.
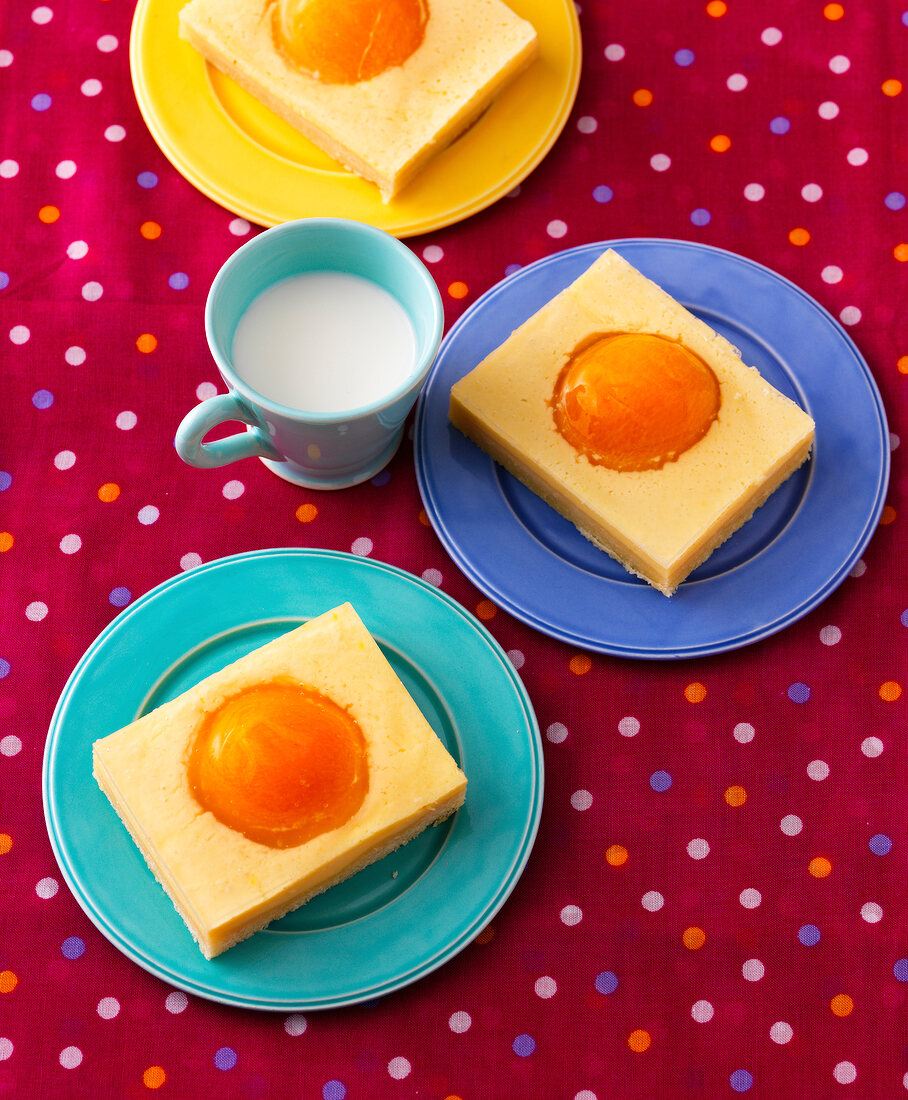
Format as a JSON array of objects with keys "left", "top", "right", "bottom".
[{"left": 174, "top": 218, "right": 445, "bottom": 488}]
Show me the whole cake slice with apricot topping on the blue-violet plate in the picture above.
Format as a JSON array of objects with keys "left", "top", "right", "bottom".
[{"left": 450, "top": 249, "right": 813, "bottom": 595}]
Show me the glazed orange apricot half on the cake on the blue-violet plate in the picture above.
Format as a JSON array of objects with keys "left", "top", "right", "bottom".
[{"left": 551, "top": 332, "right": 722, "bottom": 471}]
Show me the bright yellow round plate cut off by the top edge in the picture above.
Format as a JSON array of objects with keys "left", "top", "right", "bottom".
[{"left": 130, "top": 0, "right": 581, "bottom": 237}]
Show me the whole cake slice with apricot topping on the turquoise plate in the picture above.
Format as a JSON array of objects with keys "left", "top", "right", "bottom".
[{"left": 94, "top": 604, "right": 467, "bottom": 958}]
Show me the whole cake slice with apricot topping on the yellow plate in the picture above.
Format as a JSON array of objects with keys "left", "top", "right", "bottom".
[{"left": 179, "top": 0, "right": 538, "bottom": 200}]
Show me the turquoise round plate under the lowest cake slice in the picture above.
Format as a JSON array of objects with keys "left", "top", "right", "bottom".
[{"left": 44, "top": 550, "right": 543, "bottom": 1011}]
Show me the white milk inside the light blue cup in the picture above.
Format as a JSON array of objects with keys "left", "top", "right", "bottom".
[{"left": 232, "top": 271, "right": 416, "bottom": 413}]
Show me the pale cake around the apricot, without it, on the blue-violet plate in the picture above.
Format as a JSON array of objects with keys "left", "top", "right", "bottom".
[{"left": 450, "top": 249, "right": 813, "bottom": 595}]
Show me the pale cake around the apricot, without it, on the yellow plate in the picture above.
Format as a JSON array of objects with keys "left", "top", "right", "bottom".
[{"left": 179, "top": 0, "right": 538, "bottom": 201}]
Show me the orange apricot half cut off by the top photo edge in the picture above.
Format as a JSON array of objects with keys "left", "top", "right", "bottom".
[{"left": 273, "top": 0, "right": 429, "bottom": 84}]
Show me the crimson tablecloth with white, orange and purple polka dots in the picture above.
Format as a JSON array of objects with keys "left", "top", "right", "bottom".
[{"left": 0, "top": 0, "right": 908, "bottom": 1100}]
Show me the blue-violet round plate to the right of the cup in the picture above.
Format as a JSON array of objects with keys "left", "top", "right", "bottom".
[{"left": 414, "top": 239, "right": 889, "bottom": 659}]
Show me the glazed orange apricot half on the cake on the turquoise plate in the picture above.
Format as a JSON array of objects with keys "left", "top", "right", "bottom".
[{"left": 188, "top": 681, "right": 369, "bottom": 848}]
